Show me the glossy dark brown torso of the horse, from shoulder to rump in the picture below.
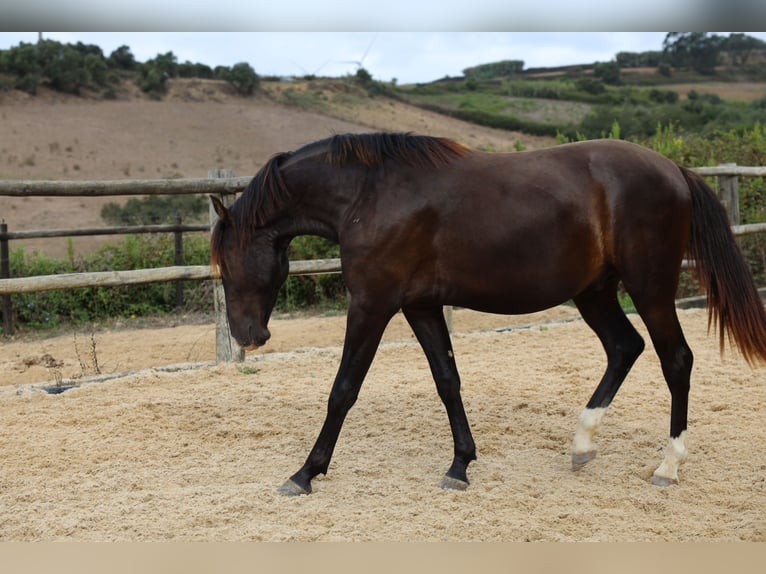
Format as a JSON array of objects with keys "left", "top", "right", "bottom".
[{"left": 344, "top": 140, "right": 689, "bottom": 313}]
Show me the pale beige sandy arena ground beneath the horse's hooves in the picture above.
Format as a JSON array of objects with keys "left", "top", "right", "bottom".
[{"left": 0, "top": 307, "right": 766, "bottom": 541}]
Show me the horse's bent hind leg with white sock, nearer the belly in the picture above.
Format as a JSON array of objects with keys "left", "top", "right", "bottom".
[{"left": 572, "top": 278, "right": 644, "bottom": 470}]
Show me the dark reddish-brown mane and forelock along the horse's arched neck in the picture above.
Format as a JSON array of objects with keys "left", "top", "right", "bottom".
[{"left": 211, "top": 132, "right": 471, "bottom": 274}]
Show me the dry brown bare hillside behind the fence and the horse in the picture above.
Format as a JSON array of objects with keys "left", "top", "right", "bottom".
[{"left": 0, "top": 79, "right": 553, "bottom": 256}]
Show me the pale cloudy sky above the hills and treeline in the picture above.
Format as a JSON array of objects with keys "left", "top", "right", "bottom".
[{"left": 0, "top": 32, "right": 766, "bottom": 84}]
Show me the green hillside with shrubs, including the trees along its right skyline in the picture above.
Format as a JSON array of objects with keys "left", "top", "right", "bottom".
[{"left": 399, "top": 32, "right": 766, "bottom": 139}]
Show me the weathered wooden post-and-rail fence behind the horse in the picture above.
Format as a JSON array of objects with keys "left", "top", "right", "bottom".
[{"left": 0, "top": 164, "right": 766, "bottom": 361}]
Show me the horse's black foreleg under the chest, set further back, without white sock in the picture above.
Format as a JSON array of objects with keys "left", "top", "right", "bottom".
[{"left": 404, "top": 307, "right": 476, "bottom": 490}]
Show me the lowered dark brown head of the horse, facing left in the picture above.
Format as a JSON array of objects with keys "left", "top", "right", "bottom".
[{"left": 211, "top": 197, "right": 289, "bottom": 350}]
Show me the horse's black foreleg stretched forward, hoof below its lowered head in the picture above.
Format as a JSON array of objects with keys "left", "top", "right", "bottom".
[{"left": 279, "top": 306, "right": 391, "bottom": 495}]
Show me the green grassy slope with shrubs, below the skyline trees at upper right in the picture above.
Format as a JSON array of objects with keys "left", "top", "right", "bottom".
[{"left": 392, "top": 62, "right": 766, "bottom": 139}]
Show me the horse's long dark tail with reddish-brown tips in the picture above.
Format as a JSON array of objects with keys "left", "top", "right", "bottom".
[{"left": 681, "top": 164, "right": 766, "bottom": 365}]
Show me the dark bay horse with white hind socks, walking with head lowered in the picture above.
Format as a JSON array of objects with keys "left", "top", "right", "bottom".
[{"left": 211, "top": 133, "right": 766, "bottom": 494}]
